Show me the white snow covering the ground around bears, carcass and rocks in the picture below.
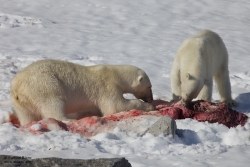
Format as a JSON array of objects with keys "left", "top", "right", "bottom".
[{"left": 0, "top": 0, "right": 250, "bottom": 167}]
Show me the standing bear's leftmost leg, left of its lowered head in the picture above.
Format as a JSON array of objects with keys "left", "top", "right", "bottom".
[{"left": 170, "top": 62, "right": 181, "bottom": 101}]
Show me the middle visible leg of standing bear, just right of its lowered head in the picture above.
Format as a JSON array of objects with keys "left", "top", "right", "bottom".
[{"left": 198, "top": 78, "right": 213, "bottom": 101}]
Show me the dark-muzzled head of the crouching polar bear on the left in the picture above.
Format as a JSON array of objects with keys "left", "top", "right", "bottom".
[{"left": 132, "top": 70, "right": 153, "bottom": 102}]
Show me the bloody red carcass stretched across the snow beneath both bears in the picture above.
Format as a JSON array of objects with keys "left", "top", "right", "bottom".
[{"left": 5, "top": 100, "right": 248, "bottom": 137}]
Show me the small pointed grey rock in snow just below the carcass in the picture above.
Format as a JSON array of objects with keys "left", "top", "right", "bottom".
[{"left": 142, "top": 115, "right": 177, "bottom": 136}]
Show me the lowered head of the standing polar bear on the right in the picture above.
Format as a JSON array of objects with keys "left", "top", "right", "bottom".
[{"left": 181, "top": 73, "right": 204, "bottom": 105}]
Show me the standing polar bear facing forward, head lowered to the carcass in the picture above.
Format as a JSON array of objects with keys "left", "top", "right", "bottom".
[{"left": 170, "top": 30, "right": 234, "bottom": 105}]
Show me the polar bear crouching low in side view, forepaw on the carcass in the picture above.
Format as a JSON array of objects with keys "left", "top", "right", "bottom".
[{"left": 10, "top": 60, "right": 154, "bottom": 125}]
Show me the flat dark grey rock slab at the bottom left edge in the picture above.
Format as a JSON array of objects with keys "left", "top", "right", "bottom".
[{"left": 0, "top": 155, "right": 131, "bottom": 167}]
